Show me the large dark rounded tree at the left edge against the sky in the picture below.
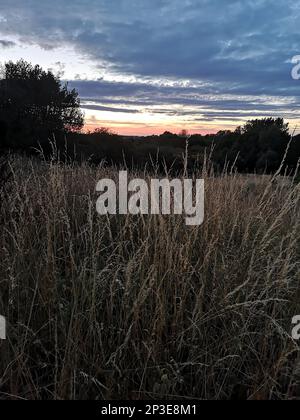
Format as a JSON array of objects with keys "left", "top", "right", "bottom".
[{"left": 0, "top": 60, "right": 84, "bottom": 148}]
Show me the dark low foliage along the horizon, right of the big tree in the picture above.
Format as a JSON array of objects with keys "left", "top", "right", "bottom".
[{"left": 65, "top": 118, "right": 300, "bottom": 173}]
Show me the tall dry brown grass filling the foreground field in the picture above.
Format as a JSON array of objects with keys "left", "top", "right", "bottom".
[{"left": 0, "top": 154, "right": 300, "bottom": 399}]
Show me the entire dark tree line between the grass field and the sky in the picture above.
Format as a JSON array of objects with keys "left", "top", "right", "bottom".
[{"left": 0, "top": 60, "right": 300, "bottom": 172}]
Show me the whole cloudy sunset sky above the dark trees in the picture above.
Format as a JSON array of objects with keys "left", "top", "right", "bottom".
[{"left": 0, "top": 0, "right": 300, "bottom": 135}]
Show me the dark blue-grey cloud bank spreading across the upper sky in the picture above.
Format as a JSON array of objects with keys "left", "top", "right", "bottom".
[{"left": 0, "top": 0, "right": 300, "bottom": 121}]
